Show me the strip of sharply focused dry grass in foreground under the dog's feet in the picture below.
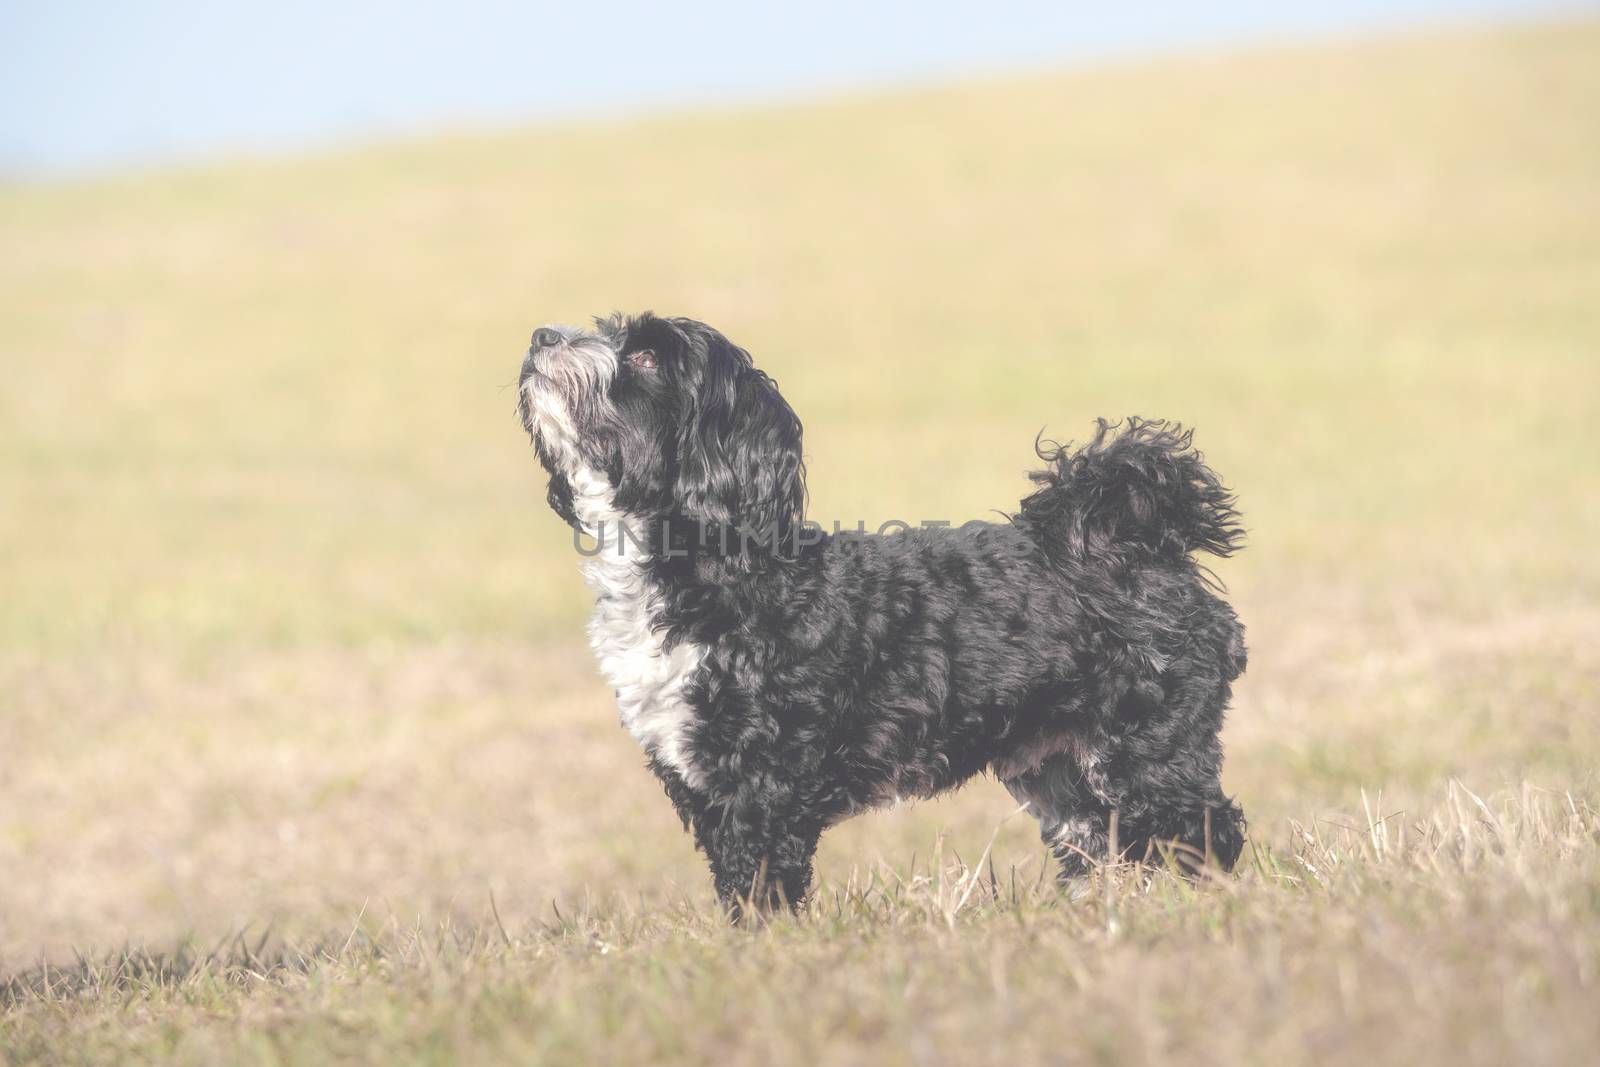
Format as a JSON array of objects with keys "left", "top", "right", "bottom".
[{"left": 0, "top": 784, "right": 1600, "bottom": 1064}]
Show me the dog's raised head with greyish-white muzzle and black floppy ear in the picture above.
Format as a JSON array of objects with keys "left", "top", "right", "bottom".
[{"left": 518, "top": 312, "right": 805, "bottom": 536}]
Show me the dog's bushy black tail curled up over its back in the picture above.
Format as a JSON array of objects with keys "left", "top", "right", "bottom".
[{"left": 1016, "top": 418, "right": 1245, "bottom": 563}]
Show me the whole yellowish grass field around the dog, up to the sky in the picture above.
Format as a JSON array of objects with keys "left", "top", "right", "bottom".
[{"left": 0, "top": 21, "right": 1600, "bottom": 1064}]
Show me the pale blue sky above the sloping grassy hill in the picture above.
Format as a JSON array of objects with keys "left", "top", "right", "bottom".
[{"left": 0, "top": 0, "right": 1594, "bottom": 176}]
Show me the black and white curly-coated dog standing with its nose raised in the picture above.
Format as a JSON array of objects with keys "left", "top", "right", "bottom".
[{"left": 518, "top": 314, "right": 1245, "bottom": 910}]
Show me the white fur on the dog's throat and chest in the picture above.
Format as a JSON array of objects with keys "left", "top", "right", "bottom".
[{"left": 571, "top": 470, "right": 706, "bottom": 785}]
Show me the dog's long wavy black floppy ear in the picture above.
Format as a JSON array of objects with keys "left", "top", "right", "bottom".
[{"left": 677, "top": 338, "right": 805, "bottom": 547}]
